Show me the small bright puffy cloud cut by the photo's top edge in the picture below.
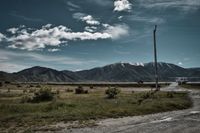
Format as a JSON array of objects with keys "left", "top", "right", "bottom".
[{"left": 114, "top": 0, "right": 132, "bottom": 12}]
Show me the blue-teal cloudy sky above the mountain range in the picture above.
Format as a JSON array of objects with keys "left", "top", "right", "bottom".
[{"left": 0, "top": 0, "right": 200, "bottom": 72}]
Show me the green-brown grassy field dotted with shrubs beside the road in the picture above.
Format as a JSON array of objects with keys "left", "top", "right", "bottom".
[{"left": 0, "top": 84, "right": 192, "bottom": 131}]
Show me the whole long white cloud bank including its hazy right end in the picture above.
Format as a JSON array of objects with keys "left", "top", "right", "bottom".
[{"left": 0, "top": 21, "right": 129, "bottom": 52}]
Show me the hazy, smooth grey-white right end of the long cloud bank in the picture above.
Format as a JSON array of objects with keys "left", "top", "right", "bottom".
[{"left": 104, "top": 24, "right": 129, "bottom": 39}]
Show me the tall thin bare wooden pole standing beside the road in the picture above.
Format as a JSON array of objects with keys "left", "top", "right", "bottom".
[{"left": 153, "top": 25, "right": 160, "bottom": 91}]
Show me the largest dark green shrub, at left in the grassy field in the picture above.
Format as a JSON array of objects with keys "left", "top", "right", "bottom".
[{"left": 30, "top": 88, "right": 54, "bottom": 103}]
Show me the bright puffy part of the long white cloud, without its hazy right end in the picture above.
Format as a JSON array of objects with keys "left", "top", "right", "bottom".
[{"left": 3, "top": 24, "right": 112, "bottom": 51}]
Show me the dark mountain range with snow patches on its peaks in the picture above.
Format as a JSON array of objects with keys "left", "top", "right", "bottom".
[{"left": 0, "top": 62, "right": 200, "bottom": 82}]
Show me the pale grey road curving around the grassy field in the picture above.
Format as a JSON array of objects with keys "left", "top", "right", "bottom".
[{"left": 59, "top": 83, "right": 200, "bottom": 133}]
